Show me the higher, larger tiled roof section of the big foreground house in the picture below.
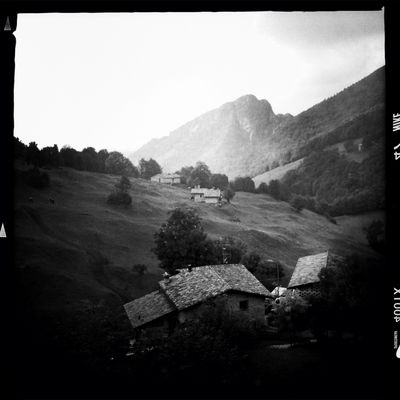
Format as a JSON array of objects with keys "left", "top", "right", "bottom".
[{"left": 159, "top": 264, "right": 269, "bottom": 310}]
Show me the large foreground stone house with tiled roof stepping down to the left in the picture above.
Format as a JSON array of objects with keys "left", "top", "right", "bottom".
[{"left": 124, "top": 264, "right": 270, "bottom": 336}]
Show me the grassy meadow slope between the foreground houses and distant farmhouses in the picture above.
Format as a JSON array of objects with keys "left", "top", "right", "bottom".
[{"left": 15, "top": 163, "right": 379, "bottom": 316}]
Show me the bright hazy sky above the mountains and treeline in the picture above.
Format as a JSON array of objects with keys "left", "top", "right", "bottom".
[{"left": 15, "top": 11, "right": 385, "bottom": 152}]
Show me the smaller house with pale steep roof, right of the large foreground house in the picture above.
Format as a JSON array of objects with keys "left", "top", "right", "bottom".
[{"left": 288, "top": 251, "right": 344, "bottom": 296}]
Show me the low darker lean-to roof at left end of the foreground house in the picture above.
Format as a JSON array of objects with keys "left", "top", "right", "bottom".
[{"left": 124, "top": 290, "right": 175, "bottom": 328}]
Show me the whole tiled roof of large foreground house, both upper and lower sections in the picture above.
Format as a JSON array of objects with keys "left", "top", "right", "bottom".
[{"left": 124, "top": 264, "right": 270, "bottom": 328}]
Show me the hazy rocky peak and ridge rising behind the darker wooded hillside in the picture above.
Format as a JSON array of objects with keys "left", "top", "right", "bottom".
[{"left": 130, "top": 67, "right": 385, "bottom": 179}]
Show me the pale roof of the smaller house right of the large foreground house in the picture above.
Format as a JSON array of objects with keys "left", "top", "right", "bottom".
[{"left": 288, "top": 251, "right": 344, "bottom": 288}]
